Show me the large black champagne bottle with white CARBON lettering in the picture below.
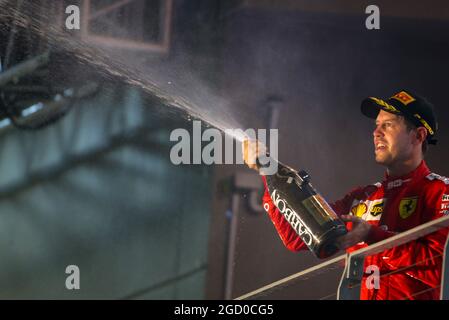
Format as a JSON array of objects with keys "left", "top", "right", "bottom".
[{"left": 257, "top": 157, "right": 347, "bottom": 259}]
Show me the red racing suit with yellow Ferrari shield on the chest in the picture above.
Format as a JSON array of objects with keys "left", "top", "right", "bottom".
[{"left": 263, "top": 161, "right": 449, "bottom": 300}]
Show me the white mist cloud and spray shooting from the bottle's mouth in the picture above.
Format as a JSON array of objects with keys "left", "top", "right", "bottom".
[{"left": 0, "top": 1, "right": 252, "bottom": 140}]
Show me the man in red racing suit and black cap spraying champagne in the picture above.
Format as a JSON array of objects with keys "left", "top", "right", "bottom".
[{"left": 243, "top": 91, "right": 449, "bottom": 300}]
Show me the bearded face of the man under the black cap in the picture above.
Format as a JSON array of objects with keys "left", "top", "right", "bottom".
[{"left": 373, "top": 110, "right": 413, "bottom": 167}]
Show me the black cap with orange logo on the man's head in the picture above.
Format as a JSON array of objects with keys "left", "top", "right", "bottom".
[{"left": 361, "top": 90, "right": 438, "bottom": 145}]
